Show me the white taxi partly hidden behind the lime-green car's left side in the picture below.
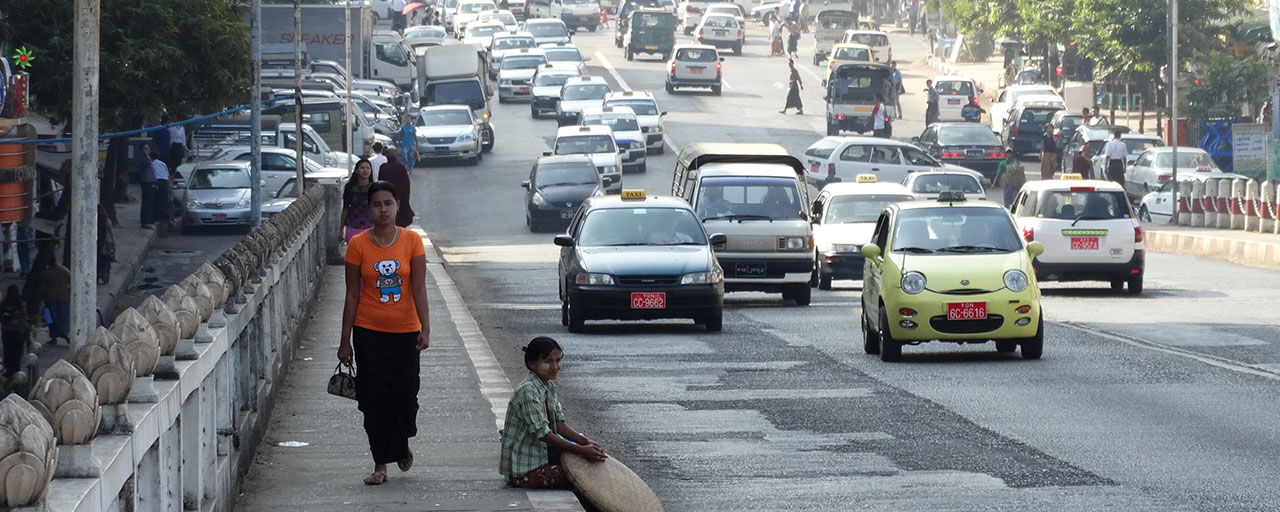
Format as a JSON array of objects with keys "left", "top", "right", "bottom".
[{"left": 809, "top": 174, "right": 915, "bottom": 289}]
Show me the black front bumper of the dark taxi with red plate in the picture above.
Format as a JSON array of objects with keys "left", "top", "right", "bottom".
[{"left": 568, "top": 283, "right": 724, "bottom": 320}]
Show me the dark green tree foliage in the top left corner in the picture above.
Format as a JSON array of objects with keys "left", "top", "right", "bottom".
[{"left": 0, "top": 0, "right": 250, "bottom": 129}]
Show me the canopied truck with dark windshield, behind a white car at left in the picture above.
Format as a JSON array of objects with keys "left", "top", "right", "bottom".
[{"left": 417, "top": 45, "right": 494, "bottom": 152}]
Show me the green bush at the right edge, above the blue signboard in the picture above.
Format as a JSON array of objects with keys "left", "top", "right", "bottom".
[{"left": 1184, "top": 51, "right": 1271, "bottom": 119}]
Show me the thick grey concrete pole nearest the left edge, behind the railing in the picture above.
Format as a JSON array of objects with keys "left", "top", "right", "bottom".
[{"left": 69, "top": 0, "right": 101, "bottom": 353}]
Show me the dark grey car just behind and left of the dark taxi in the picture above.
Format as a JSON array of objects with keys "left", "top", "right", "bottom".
[{"left": 520, "top": 155, "right": 604, "bottom": 232}]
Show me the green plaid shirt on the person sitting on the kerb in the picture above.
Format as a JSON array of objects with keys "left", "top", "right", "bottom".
[{"left": 498, "top": 371, "right": 564, "bottom": 479}]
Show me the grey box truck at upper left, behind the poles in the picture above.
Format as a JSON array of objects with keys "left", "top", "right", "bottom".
[{"left": 262, "top": 4, "right": 417, "bottom": 91}]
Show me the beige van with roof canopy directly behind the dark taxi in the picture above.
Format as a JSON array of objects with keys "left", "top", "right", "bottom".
[{"left": 671, "top": 143, "right": 814, "bottom": 306}]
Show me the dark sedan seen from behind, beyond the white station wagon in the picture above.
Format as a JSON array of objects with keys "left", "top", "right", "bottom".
[{"left": 911, "top": 123, "right": 1005, "bottom": 179}]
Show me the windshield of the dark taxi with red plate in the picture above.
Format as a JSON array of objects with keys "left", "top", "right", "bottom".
[{"left": 577, "top": 207, "right": 707, "bottom": 247}]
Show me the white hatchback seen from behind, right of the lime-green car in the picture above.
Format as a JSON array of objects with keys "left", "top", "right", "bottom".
[{"left": 1010, "top": 174, "right": 1146, "bottom": 294}]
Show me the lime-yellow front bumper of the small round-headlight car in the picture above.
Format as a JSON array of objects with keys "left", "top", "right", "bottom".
[{"left": 884, "top": 290, "right": 1041, "bottom": 343}]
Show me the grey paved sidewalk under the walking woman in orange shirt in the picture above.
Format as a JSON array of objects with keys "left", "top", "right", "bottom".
[{"left": 236, "top": 230, "right": 582, "bottom": 511}]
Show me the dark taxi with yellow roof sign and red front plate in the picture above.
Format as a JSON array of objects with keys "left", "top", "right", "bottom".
[{"left": 556, "top": 191, "right": 724, "bottom": 333}]
